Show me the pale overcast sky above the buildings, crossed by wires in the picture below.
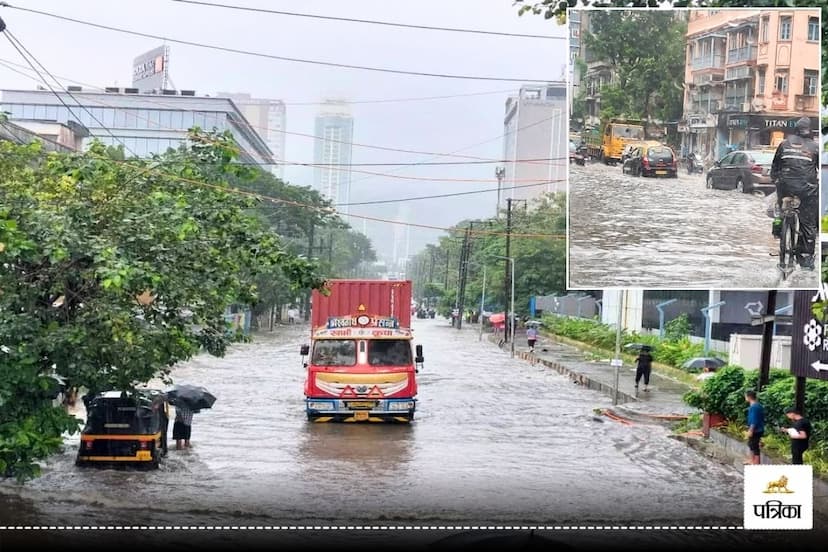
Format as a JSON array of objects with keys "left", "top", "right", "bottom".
[{"left": 0, "top": 0, "right": 567, "bottom": 264}]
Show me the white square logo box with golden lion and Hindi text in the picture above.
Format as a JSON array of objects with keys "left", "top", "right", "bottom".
[{"left": 744, "top": 464, "right": 814, "bottom": 529}]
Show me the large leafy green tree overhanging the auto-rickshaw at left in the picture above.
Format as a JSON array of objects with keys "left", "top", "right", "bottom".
[{"left": 0, "top": 130, "right": 322, "bottom": 479}]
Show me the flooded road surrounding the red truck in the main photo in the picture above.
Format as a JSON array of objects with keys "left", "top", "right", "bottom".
[{"left": 0, "top": 320, "right": 824, "bottom": 542}]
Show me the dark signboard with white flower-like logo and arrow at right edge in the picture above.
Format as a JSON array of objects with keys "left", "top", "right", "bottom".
[{"left": 791, "top": 284, "right": 828, "bottom": 380}]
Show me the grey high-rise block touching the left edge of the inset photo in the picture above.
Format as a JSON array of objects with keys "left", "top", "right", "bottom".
[{"left": 503, "top": 82, "right": 569, "bottom": 203}]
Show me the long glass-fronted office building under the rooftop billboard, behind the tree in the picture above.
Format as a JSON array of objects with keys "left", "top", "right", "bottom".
[{"left": 0, "top": 89, "right": 275, "bottom": 164}]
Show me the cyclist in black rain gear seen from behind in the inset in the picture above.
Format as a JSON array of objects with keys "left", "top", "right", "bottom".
[{"left": 771, "top": 117, "right": 819, "bottom": 269}]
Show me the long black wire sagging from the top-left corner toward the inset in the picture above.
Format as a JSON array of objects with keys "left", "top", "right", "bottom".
[{"left": 3, "top": 3, "right": 550, "bottom": 83}]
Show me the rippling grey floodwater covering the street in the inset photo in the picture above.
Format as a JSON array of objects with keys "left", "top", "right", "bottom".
[{"left": 569, "top": 163, "right": 819, "bottom": 289}]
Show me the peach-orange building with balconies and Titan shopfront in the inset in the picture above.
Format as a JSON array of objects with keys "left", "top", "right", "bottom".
[{"left": 681, "top": 9, "right": 821, "bottom": 159}]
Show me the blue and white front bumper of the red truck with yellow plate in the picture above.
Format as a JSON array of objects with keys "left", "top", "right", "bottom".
[{"left": 305, "top": 397, "right": 417, "bottom": 423}]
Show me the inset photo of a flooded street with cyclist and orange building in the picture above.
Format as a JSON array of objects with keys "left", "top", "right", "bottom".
[{"left": 567, "top": 8, "right": 825, "bottom": 290}]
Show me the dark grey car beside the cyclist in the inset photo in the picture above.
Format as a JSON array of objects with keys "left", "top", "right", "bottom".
[{"left": 707, "top": 150, "right": 776, "bottom": 195}]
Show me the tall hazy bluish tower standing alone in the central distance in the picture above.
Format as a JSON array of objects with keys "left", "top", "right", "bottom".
[{"left": 313, "top": 100, "right": 354, "bottom": 214}]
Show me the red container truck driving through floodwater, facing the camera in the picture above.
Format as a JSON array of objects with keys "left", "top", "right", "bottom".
[{"left": 301, "top": 280, "right": 423, "bottom": 423}]
